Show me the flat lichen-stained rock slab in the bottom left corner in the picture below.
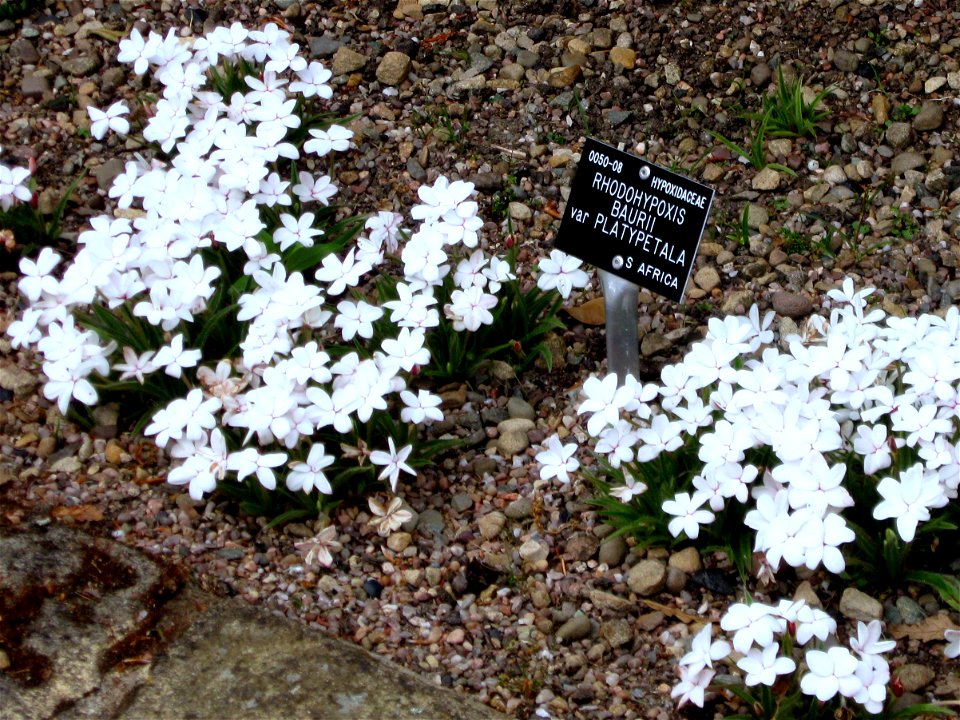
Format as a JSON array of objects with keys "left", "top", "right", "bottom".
[{"left": 0, "top": 525, "right": 504, "bottom": 720}]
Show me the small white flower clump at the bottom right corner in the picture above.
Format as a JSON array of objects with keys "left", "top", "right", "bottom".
[{"left": 671, "top": 600, "right": 896, "bottom": 714}]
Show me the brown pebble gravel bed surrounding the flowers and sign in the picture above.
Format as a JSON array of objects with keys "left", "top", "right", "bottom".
[{"left": 0, "top": 0, "right": 960, "bottom": 718}]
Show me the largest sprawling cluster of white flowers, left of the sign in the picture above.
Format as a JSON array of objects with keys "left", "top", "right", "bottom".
[{"left": 8, "top": 23, "right": 513, "bottom": 498}]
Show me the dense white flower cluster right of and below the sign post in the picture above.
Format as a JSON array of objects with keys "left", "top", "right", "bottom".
[{"left": 538, "top": 279, "right": 960, "bottom": 573}]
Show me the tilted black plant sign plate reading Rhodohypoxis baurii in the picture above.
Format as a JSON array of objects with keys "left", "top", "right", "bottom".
[{"left": 556, "top": 138, "right": 713, "bottom": 302}]
